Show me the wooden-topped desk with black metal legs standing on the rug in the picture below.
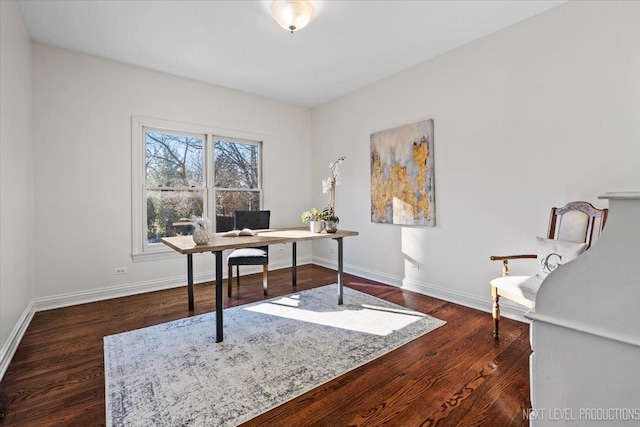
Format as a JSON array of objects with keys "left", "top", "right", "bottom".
[{"left": 161, "top": 227, "right": 358, "bottom": 342}]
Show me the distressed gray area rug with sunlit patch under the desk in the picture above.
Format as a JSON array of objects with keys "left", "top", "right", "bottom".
[{"left": 104, "top": 285, "right": 445, "bottom": 426}]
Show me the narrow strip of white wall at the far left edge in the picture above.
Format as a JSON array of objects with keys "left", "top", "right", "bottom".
[{"left": 0, "top": 1, "right": 34, "bottom": 378}]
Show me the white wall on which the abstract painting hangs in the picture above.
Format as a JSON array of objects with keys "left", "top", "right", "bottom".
[{"left": 312, "top": 1, "right": 640, "bottom": 310}]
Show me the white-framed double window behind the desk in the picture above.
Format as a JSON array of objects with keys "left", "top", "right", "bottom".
[{"left": 132, "top": 117, "right": 264, "bottom": 261}]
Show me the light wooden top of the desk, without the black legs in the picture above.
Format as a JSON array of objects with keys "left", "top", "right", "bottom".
[{"left": 161, "top": 227, "right": 358, "bottom": 254}]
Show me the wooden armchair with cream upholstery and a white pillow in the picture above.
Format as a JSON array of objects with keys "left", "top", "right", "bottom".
[{"left": 490, "top": 202, "right": 608, "bottom": 339}]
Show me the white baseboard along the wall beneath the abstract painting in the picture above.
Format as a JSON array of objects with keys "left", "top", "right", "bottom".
[{"left": 313, "top": 257, "right": 531, "bottom": 323}]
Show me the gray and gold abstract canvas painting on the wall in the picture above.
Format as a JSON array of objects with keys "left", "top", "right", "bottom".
[{"left": 371, "top": 119, "right": 435, "bottom": 227}]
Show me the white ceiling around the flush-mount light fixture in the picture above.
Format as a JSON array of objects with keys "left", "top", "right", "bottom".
[{"left": 19, "top": 0, "right": 563, "bottom": 107}]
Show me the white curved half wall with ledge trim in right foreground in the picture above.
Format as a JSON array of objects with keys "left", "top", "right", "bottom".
[{"left": 523, "top": 192, "right": 640, "bottom": 427}]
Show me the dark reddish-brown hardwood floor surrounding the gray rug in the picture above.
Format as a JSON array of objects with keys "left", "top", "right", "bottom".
[{"left": 0, "top": 265, "right": 531, "bottom": 427}]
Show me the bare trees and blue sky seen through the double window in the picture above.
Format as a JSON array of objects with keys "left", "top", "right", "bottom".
[{"left": 144, "top": 129, "right": 262, "bottom": 244}]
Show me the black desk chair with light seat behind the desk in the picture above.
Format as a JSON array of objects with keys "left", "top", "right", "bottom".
[{"left": 227, "top": 211, "right": 271, "bottom": 297}]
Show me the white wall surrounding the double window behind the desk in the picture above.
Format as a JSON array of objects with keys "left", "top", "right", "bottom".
[{"left": 33, "top": 43, "right": 311, "bottom": 306}]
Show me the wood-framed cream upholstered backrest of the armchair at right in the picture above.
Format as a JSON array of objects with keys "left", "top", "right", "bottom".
[{"left": 547, "top": 202, "right": 609, "bottom": 248}]
